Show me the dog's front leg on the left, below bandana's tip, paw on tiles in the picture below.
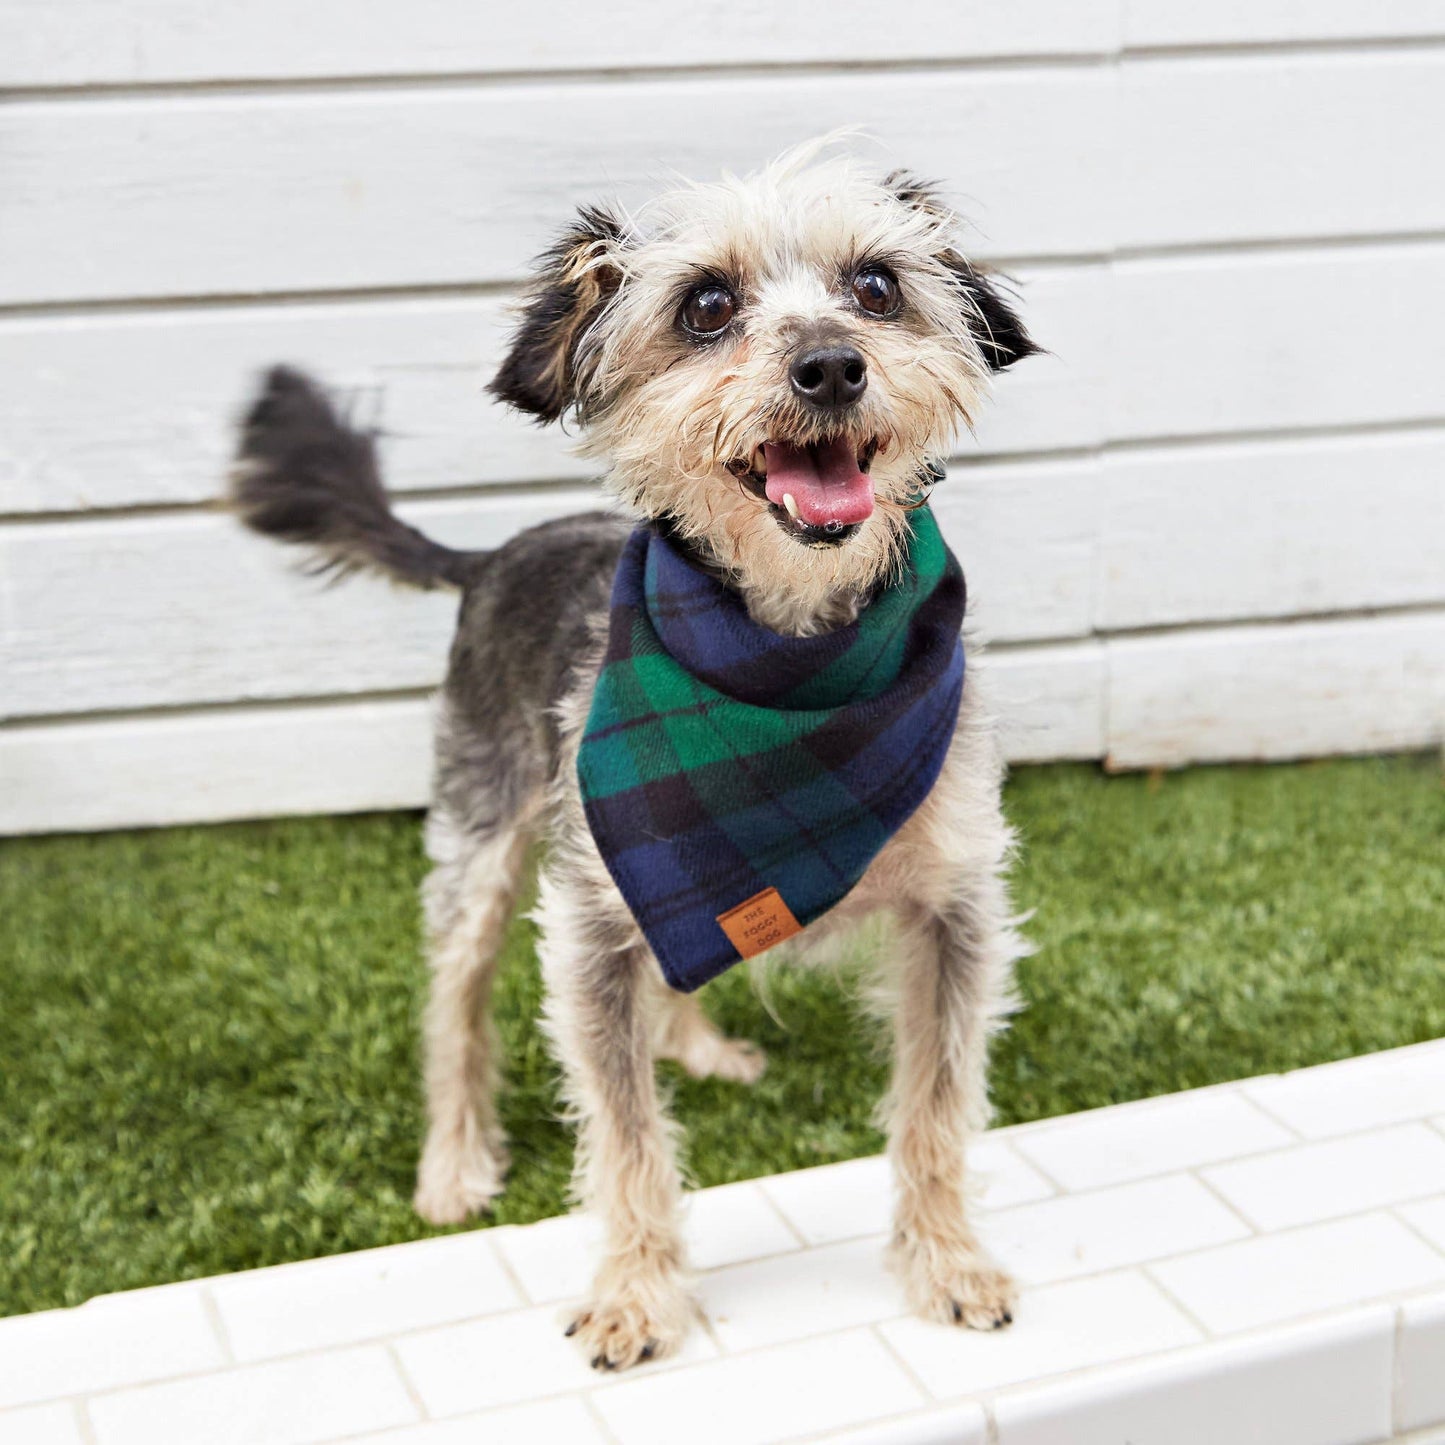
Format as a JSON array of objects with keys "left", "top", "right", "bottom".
[{"left": 540, "top": 880, "right": 694, "bottom": 1370}]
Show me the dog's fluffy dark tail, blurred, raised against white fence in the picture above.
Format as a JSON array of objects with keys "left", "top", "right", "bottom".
[{"left": 231, "top": 366, "right": 487, "bottom": 587}]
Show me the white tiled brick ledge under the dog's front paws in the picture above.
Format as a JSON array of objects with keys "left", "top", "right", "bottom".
[{"left": 0, "top": 1040, "right": 1445, "bottom": 1445}]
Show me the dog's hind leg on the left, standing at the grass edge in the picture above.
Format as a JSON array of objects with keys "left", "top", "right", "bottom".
[{"left": 413, "top": 814, "right": 530, "bottom": 1224}]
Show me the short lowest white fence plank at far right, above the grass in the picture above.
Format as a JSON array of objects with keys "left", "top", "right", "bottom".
[{"left": 1105, "top": 610, "right": 1445, "bottom": 769}]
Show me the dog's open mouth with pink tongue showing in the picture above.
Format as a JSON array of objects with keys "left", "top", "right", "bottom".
[{"left": 728, "top": 436, "right": 879, "bottom": 546}]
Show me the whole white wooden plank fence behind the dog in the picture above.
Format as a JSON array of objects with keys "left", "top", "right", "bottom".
[{"left": 0, "top": 0, "right": 1445, "bottom": 832}]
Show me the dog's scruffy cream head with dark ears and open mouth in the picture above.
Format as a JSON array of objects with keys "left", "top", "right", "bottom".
[{"left": 493, "top": 143, "right": 1036, "bottom": 621}]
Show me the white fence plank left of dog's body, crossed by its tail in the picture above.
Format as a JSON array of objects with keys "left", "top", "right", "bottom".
[{"left": 0, "top": 490, "right": 597, "bottom": 717}]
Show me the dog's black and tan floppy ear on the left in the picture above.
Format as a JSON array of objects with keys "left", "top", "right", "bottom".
[{"left": 488, "top": 207, "right": 623, "bottom": 422}]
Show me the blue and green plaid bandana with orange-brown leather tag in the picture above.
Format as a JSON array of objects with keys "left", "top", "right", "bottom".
[{"left": 577, "top": 507, "right": 964, "bottom": 993}]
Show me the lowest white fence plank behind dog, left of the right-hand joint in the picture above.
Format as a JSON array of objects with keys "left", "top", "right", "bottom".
[{"left": 0, "top": 644, "right": 1103, "bottom": 834}]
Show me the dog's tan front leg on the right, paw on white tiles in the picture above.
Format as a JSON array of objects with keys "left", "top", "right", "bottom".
[{"left": 889, "top": 877, "right": 1017, "bottom": 1329}]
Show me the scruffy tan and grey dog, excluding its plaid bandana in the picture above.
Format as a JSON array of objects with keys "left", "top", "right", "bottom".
[{"left": 234, "top": 146, "right": 1036, "bottom": 1370}]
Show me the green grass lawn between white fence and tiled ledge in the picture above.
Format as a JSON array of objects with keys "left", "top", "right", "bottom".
[{"left": 0, "top": 757, "right": 1445, "bottom": 1314}]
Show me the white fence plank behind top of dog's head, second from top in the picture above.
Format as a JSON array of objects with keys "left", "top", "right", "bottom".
[{"left": 0, "top": 49, "right": 1445, "bottom": 303}]
